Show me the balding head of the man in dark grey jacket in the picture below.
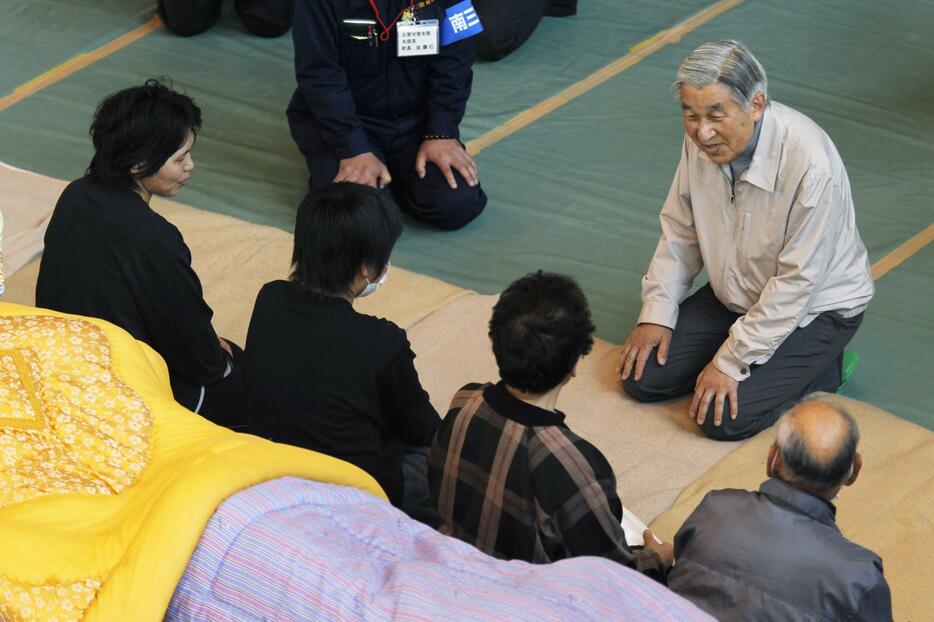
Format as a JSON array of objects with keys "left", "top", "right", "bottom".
[{"left": 775, "top": 400, "right": 859, "bottom": 493}]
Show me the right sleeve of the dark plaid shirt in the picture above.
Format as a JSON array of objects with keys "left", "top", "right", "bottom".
[{"left": 532, "top": 434, "right": 667, "bottom": 583}]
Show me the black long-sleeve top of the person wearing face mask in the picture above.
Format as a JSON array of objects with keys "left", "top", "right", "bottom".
[{"left": 243, "top": 281, "right": 441, "bottom": 504}]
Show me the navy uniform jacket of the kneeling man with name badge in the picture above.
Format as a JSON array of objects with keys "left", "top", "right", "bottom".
[{"left": 288, "top": 0, "right": 474, "bottom": 159}]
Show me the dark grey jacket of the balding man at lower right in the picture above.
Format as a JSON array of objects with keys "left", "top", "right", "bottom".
[{"left": 668, "top": 478, "right": 892, "bottom": 622}]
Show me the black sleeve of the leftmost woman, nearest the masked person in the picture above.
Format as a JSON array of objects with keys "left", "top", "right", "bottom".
[{"left": 122, "top": 229, "right": 227, "bottom": 385}]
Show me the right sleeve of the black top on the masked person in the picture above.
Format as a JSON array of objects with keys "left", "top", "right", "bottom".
[{"left": 377, "top": 337, "right": 441, "bottom": 447}]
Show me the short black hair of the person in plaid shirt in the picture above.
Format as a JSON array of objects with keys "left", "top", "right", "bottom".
[{"left": 490, "top": 270, "right": 594, "bottom": 395}]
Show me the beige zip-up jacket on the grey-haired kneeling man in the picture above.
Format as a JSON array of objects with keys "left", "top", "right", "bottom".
[{"left": 639, "top": 102, "right": 875, "bottom": 381}]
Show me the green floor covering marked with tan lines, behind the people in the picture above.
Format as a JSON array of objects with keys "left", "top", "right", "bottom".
[{"left": 0, "top": 0, "right": 934, "bottom": 429}]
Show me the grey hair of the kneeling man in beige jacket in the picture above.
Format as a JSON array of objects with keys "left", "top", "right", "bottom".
[{"left": 673, "top": 40, "right": 768, "bottom": 110}]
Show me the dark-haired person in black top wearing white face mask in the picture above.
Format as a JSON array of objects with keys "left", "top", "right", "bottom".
[{"left": 243, "top": 183, "right": 441, "bottom": 525}]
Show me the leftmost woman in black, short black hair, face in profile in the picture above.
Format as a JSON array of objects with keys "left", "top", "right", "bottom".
[{"left": 36, "top": 80, "right": 241, "bottom": 427}]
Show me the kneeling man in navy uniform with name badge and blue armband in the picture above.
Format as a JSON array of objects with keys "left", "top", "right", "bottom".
[{"left": 287, "top": 0, "right": 487, "bottom": 229}]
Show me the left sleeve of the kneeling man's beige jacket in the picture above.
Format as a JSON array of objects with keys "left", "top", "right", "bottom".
[{"left": 639, "top": 138, "right": 704, "bottom": 329}]
